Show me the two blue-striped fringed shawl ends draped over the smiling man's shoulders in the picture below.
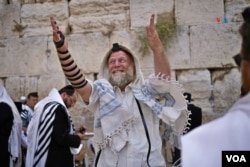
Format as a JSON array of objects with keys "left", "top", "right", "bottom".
[{"left": 94, "top": 75, "right": 190, "bottom": 152}]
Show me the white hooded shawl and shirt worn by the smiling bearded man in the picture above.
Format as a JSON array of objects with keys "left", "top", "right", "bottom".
[{"left": 80, "top": 44, "right": 189, "bottom": 167}]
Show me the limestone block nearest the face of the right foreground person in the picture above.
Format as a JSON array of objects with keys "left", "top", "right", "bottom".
[{"left": 212, "top": 68, "right": 241, "bottom": 113}]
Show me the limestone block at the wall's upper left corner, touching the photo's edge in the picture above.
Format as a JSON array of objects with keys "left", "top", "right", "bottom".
[{"left": 0, "top": 3, "right": 20, "bottom": 39}]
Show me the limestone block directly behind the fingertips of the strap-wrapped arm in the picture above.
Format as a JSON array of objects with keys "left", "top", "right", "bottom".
[{"left": 21, "top": 0, "right": 69, "bottom": 37}]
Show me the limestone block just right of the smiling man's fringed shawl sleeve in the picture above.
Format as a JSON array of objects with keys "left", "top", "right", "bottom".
[{"left": 176, "top": 70, "right": 212, "bottom": 112}]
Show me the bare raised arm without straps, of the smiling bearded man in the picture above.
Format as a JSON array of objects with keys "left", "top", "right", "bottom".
[{"left": 146, "top": 14, "right": 171, "bottom": 78}]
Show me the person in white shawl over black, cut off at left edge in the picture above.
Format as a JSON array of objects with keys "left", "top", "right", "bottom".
[{"left": 0, "top": 84, "right": 22, "bottom": 167}]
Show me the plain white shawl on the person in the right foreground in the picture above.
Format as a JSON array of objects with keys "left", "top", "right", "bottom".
[{"left": 181, "top": 93, "right": 250, "bottom": 167}]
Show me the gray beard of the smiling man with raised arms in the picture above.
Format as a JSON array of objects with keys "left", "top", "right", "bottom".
[{"left": 109, "top": 66, "right": 134, "bottom": 89}]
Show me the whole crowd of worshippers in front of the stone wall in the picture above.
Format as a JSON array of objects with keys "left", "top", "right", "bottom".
[{"left": 0, "top": 8, "right": 250, "bottom": 167}]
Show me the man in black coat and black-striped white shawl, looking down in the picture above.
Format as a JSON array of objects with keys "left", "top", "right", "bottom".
[{"left": 26, "top": 85, "right": 84, "bottom": 167}]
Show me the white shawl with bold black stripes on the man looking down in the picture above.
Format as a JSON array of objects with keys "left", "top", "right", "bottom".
[{"left": 26, "top": 88, "right": 74, "bottom": 167}]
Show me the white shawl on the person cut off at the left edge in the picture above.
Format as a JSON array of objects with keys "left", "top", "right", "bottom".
[{"left": 0, "top": 84, "right": 22, "bottom": 167}]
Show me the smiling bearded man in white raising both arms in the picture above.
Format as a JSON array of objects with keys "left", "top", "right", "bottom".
[{"left": 51, "top": 15, "right": 188, "bottom": 167}]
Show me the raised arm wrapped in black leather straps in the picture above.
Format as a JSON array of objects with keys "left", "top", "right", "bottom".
[{"left": 50, "top": 17, "right": 92, "bottom": 103}]
